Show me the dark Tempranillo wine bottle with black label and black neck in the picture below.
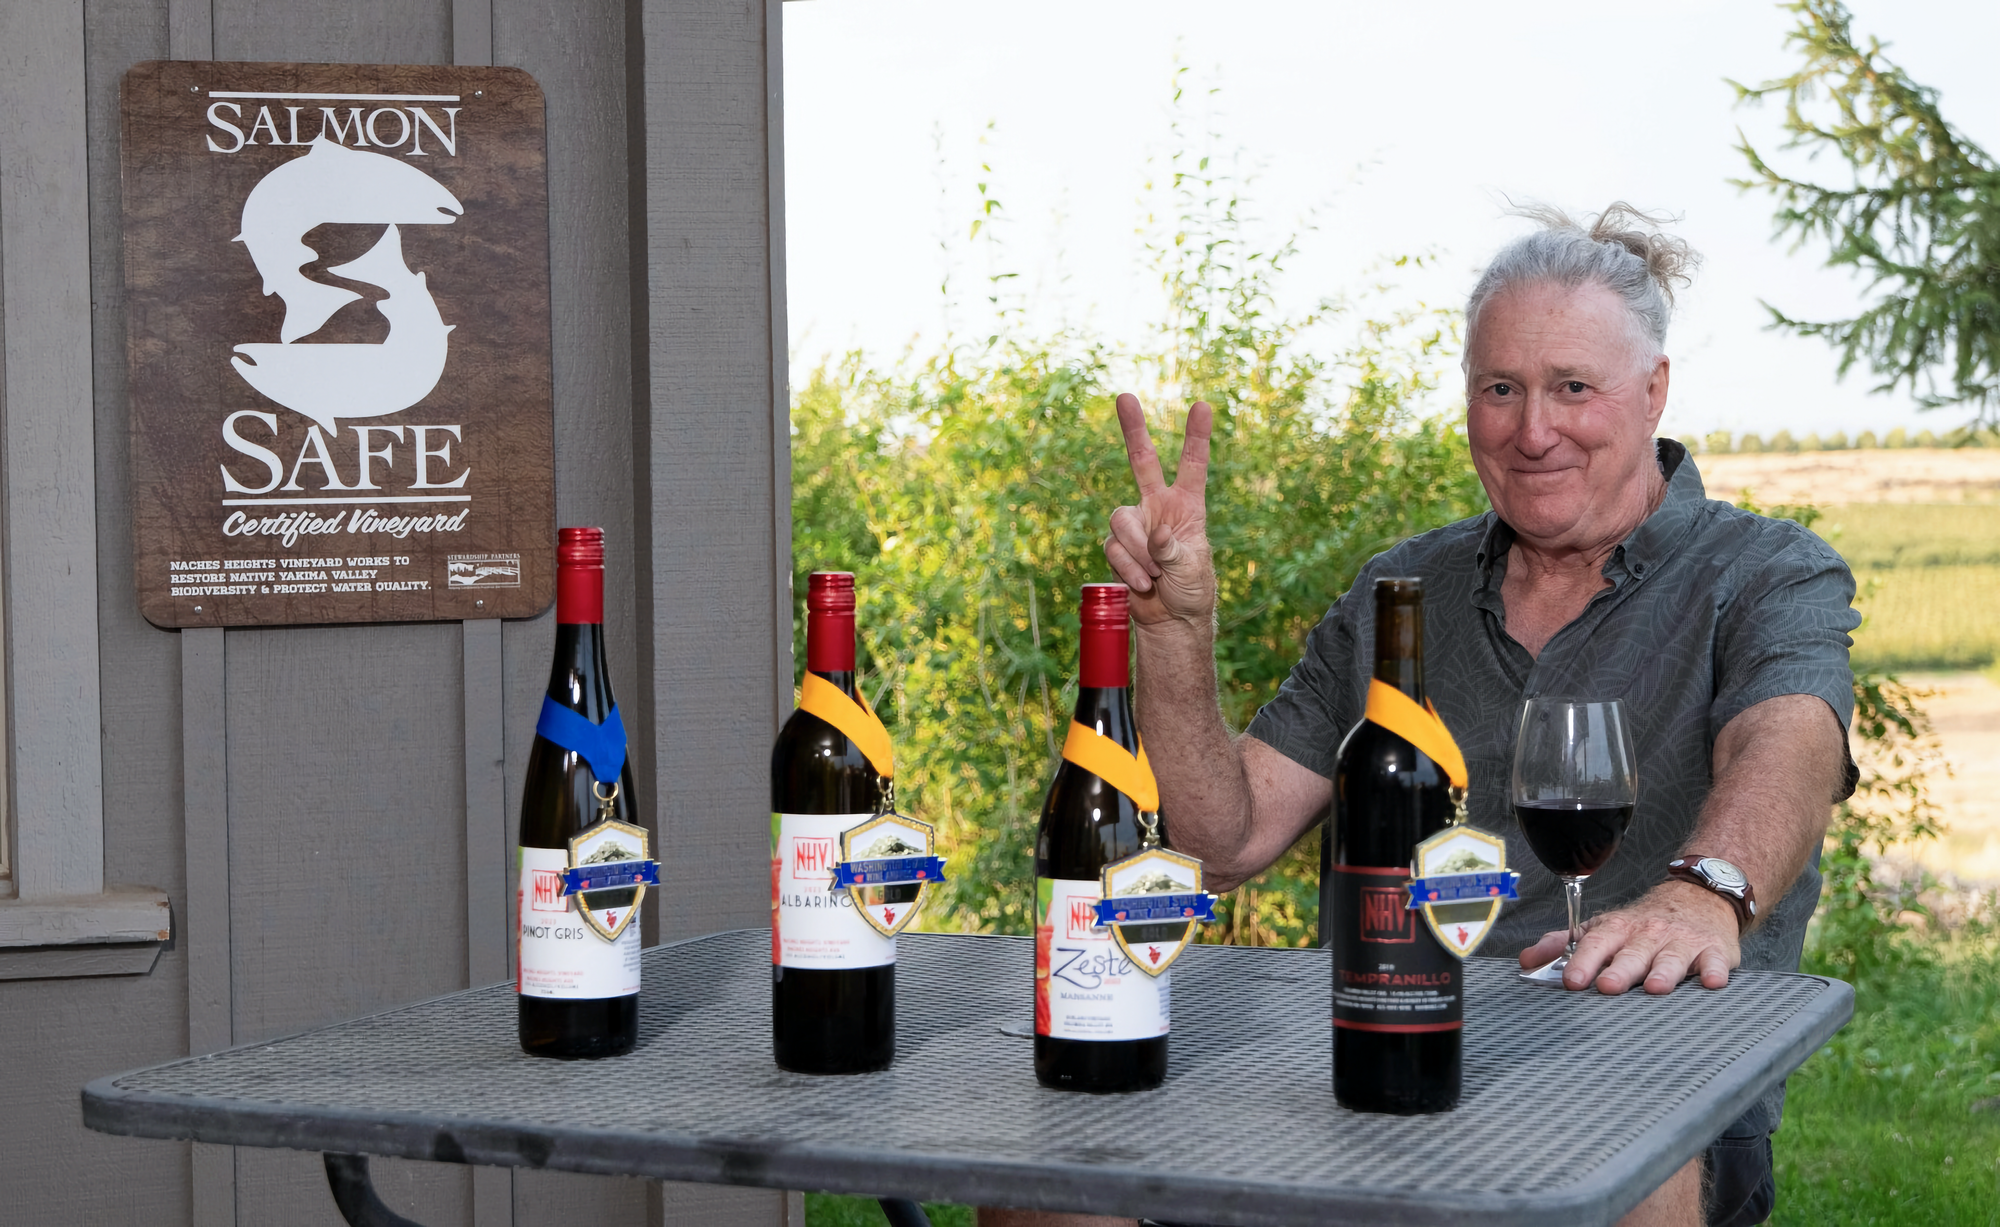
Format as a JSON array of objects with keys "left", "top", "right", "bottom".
[{"left": 1324, "top": 580, "right": 1464, "bottom": 1115}]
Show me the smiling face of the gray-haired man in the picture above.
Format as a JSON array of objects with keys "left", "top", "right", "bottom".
[{"left": 1466, "top": 284, "right": 1666, "bottom": 550}]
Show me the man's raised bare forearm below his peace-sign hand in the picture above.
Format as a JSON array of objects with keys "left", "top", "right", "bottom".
[{"left": 1134, "top": 621, "right": 1262, "bottom": 889}]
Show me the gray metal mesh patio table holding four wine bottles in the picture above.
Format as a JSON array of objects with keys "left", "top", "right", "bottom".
[{"left": 84, "top": 929, "right": 1854, "bottom": 1227}]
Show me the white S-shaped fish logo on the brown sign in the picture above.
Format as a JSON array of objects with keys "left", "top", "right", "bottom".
[{"left": 230, "top": 136, "right": 464, "bottom": 432}]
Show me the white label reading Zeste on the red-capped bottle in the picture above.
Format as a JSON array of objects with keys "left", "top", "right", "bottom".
[{"left": 1034, "top": 877, "right": 1174, "bottom": 1039}]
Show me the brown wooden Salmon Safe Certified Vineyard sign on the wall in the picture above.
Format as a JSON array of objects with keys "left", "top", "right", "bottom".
[{"left": 122, "top": 60, "right": 556, "bottom": 627}]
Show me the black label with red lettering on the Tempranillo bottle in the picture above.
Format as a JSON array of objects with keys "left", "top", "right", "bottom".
[{"left": 1332, "top": 865, "right": 1464, "bottom": 1033}]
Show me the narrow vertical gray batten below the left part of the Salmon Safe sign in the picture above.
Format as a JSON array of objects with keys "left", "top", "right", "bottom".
[{"left": 180, "top": 627, "right": 236, "bottom": 1227}]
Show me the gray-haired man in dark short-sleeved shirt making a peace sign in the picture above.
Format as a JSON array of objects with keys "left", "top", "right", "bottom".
[{"left": 982, "top": 206, "right": 1860, "bottom": 1227}]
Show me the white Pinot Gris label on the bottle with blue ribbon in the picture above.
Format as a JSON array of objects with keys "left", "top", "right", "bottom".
[{"left": 514, "top": 847, "right": 638, "bottom": 1001}]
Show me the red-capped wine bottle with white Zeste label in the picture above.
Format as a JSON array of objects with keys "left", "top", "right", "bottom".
[{"left": 1034, "top": 584, "right": 1174, "bottom": 1093}]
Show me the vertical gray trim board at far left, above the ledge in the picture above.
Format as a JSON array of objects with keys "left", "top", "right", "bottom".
[{"left": 0, "top": 0, "right": 104, "bottom": 899}]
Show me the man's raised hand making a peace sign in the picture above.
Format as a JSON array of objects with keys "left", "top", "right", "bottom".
[{"left": 1104, "top": 392, "right": 1216, "bottom": 635}]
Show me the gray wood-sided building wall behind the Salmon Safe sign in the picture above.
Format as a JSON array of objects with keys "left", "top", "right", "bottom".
[{"left": 0, "top": 0, "right": 796, "bottom": 1227}]
